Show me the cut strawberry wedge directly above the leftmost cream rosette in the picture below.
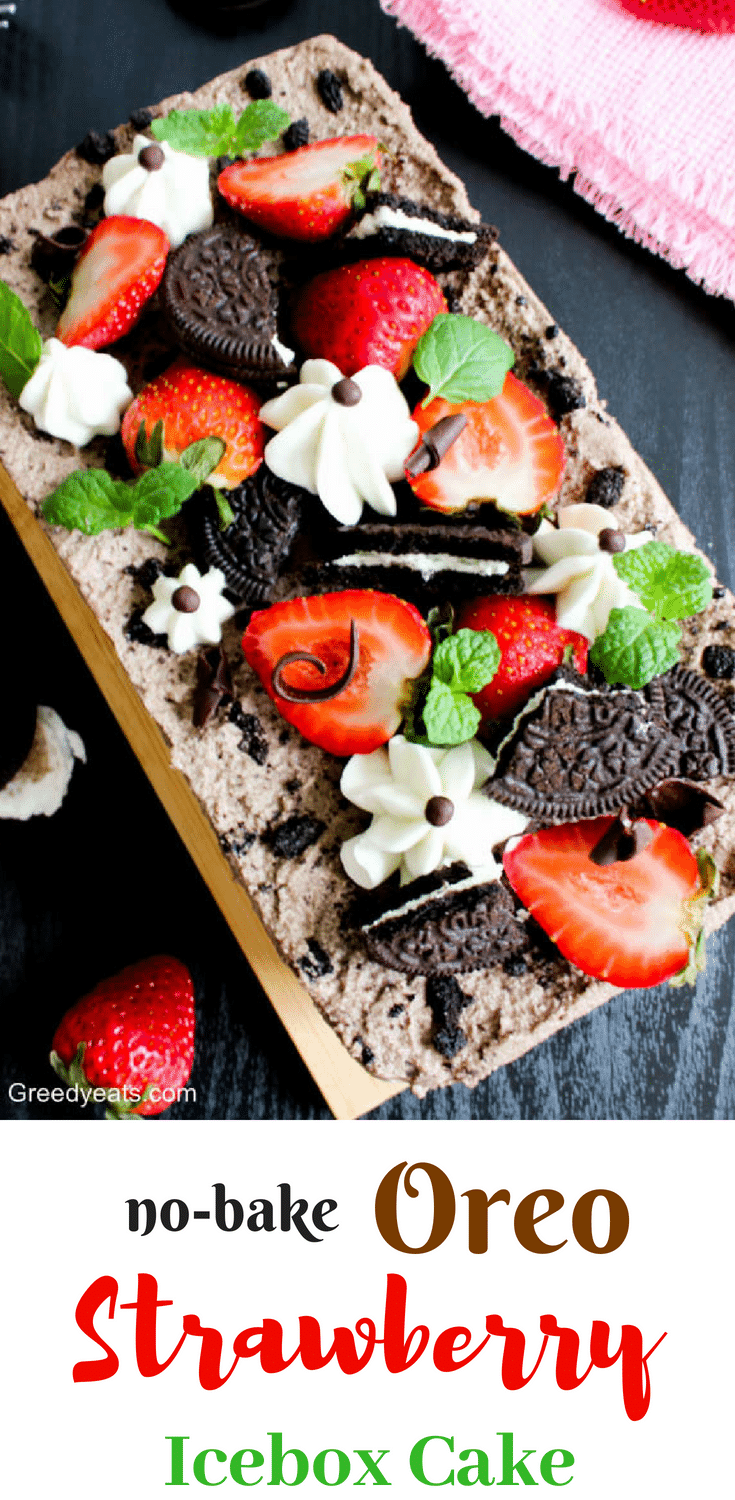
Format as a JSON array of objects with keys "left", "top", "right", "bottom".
[{"left": 56, "top": 213, "right": 170, "bottom": 350}]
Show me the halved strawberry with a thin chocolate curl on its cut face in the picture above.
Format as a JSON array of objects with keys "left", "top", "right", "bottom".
[{"left": 243, "top": 590, "right": 432, "bottom": 756}]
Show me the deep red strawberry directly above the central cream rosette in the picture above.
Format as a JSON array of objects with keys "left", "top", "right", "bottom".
[{"left": 293, "top": 255, "right": 447, "bottom": 380}]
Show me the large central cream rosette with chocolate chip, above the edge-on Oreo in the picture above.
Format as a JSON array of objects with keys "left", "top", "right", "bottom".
[{"left": 260, "top": 360, "right": 419, "bottom": 525}]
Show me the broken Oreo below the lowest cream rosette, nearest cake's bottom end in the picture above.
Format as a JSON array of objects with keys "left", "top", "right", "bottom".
[{"left": 357, "top": 866, "right": 528, "bottom": 974}]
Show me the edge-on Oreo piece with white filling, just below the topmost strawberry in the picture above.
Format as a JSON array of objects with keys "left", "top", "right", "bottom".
[{"left": 339, "top": 192, "right": 498, "bottom": 272}]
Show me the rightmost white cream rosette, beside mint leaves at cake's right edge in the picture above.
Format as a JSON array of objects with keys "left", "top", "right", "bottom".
[{"left": 527, "top": 504, "right": 654, "bottom": 642}]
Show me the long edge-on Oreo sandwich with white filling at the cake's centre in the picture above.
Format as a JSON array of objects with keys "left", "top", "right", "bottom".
[{"left": 318, "top": 522, "right": 531, "bottom": 609}]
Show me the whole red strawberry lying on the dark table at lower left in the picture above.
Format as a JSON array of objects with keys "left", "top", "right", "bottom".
[{"left": 51, "top": 956, "right": 194, "bottom": 1119}]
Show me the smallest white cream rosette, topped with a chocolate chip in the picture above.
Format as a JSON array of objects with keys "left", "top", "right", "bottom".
[{"left": 143, "top": 563, "right": 236, "bottom": 654}]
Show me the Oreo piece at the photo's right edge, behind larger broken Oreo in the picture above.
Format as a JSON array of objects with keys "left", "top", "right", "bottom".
[{"left": 647, "top": 666, "right": 735, "bottom": 782}]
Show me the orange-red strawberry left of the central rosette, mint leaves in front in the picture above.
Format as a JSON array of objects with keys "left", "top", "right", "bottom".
[{"left": 122, "top": 359, "right": 266, "bottom": 489}]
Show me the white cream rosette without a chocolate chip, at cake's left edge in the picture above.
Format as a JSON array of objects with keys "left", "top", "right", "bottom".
[{"left": 20, "top": 339, "right": 132, "bottom": 449}]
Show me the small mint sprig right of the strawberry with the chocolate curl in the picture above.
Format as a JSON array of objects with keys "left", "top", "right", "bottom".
[{"left": 404, "top": 627, "right": 500, "bottom": 746}]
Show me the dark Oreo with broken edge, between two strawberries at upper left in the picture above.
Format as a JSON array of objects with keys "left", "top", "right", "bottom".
[{"left": 161, "top": 224, "right": 294, "bottom": 384}]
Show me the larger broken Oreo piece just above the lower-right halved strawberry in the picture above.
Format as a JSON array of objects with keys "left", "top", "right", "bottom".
[{"left": 486, "top": 669, "right": 680, "bottom": 824}]
